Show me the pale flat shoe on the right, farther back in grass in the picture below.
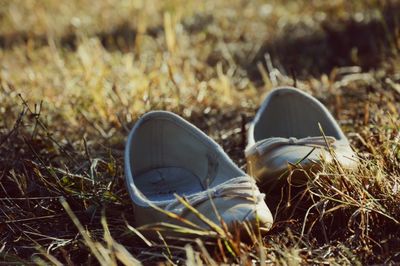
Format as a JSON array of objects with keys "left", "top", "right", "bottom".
[{"left": 245, "top": 87, "right": 358, "bottom": 183}]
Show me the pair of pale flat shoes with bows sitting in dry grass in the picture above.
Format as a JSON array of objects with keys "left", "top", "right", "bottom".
[{"left": 125, "top": 88, "right": 356, "bottom": 236}]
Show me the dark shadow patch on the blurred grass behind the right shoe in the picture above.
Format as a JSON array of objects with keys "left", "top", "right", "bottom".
[{"left": 247, "top": 4, "right": 400, "bottom": 81}]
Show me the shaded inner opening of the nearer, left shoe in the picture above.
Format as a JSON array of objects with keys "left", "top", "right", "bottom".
[{"left": 129, "top": 113, "right": 242, "bottom": 201}]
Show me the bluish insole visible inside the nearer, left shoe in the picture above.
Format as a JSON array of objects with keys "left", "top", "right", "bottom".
[{"left": 134, "top": 167, "right": 203, "bottom": 201}]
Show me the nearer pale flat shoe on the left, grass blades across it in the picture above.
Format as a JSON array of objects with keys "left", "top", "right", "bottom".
[{"left": 125, "top": 111, "right": 272, "bottom": 236}]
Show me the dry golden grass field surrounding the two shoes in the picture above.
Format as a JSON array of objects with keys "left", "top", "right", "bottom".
[{"left": 0, "top": 0, "right": 400, "bottom": 265}]
